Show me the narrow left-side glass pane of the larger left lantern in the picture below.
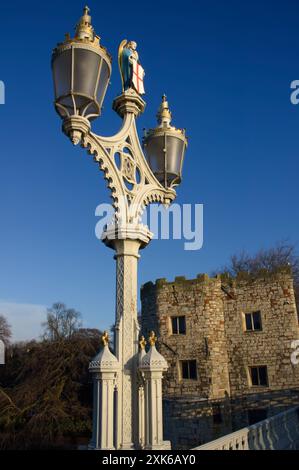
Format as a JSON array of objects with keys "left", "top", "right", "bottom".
[{"left": 53, "top": 49, "right": 72, "bottom": 98}]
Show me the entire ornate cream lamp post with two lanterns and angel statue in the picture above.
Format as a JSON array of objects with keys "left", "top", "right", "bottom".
[{"left": 52, "top": 7, "right": 187, "bottom": 449}]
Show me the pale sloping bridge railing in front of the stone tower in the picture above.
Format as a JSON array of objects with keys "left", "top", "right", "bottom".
[{"left": 193, "top": 407, "right": 299, "bottom": 450}]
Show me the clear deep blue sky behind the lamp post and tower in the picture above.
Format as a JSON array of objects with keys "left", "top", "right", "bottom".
[{"left": 0, "top": 0, "right": 299, "bottom": 339}]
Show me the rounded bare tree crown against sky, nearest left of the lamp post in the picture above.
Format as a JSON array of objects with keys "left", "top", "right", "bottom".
[{"left": 42, "top": 302, "right": 82, "bottom": 341}]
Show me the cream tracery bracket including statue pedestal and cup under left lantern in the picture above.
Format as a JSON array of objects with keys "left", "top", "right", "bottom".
[{"left": 63, "top": 89, "right": 176, "bottom": 226}]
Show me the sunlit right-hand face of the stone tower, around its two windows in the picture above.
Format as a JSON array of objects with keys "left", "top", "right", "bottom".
[{"left": 223, "top": 275, "right": 299, "bottom": 396}]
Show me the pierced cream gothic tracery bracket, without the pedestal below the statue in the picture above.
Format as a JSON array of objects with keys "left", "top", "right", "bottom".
[{"left": 77, "top": 113, "right": 176, "bottom": 224}]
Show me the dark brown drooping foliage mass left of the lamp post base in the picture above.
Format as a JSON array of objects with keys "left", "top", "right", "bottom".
[{"left": 0, "top": 329, "right": 102, "bottom": 449}]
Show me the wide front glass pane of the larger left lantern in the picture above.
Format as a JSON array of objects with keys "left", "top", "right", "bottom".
[{"left": 74, "top": 48, "right": 101, "bottom": 97}]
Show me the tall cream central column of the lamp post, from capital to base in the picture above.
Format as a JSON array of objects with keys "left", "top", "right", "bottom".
[{"left": 104, "top": 226, "right": 151, "bottom": 450}]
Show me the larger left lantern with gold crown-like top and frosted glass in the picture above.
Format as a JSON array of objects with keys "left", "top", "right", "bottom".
[{"left": 52, "top": 7, "right": 111, "bottom": 120}]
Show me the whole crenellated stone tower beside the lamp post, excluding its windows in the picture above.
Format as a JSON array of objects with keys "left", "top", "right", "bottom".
[{"left": 141, "top": 272, "right": 299, "bottom": 448}]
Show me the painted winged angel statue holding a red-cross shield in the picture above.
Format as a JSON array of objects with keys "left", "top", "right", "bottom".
[{"left": 118, "top": 39, "right": 145, "bottom": 95}]
